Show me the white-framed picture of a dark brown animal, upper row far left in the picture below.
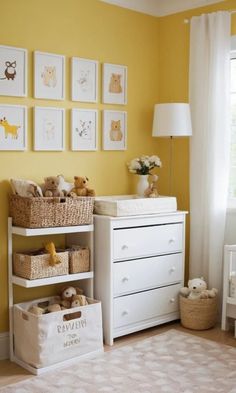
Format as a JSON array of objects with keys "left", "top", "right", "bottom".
[{"left": 0, "top": 45, "right": 28, "bottom": 97}]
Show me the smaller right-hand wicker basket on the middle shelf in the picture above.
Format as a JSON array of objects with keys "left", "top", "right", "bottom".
[{"left": 68, "top": 246, "right": 90, "bottom": 274}]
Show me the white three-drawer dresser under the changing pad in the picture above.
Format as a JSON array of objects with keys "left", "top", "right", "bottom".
[{"left": 94, "top": 211, "right": 186, "bottom": 345}]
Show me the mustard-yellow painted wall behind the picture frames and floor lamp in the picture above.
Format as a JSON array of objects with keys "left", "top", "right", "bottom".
[{"left": 0, "top": 0, "right": 236, "bottom": 332}]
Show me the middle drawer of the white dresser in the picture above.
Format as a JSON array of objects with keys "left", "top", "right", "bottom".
[{"left": 113, "top": 253, "right": 183, "bottom": 296}]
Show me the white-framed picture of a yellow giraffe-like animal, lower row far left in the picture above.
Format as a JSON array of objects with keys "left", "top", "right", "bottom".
[{"left": 0, "top": 104, "right": 27, "bottom": 151}]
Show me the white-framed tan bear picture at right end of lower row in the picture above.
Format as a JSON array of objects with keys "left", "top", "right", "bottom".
[{"left": 103, "top": 110, "right": 127, "bottom": 150}]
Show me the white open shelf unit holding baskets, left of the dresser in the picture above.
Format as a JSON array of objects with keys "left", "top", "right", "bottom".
[{"left": 8, "top": 217, "right": 94, "bottom": 375}]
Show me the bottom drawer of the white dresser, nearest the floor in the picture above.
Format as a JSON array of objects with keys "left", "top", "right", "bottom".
[{"left": 114, "top": 284, "right": 181, "bottom": 329}]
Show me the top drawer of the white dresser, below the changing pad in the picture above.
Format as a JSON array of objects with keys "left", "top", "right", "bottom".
[{"left": 113, "top": 223, "right": 183, "bottom": 260}]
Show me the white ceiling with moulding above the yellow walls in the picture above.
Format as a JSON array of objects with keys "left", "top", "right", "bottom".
[{"left": 101, "top": 0, "right": 224, "bottom": 16}]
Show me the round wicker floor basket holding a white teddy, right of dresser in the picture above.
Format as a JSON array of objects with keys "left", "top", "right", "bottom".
[{"left": 179, "top": 295, "right": 217, "bottom": 330}]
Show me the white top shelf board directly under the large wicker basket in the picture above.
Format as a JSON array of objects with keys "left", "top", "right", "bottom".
[{"left": 12, "top": 224, "right": 94, "bottom": 236}]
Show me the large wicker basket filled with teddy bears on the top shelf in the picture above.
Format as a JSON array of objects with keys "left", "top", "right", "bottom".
[{"left": 9, "top": 195, "right": 94, "bottom": 228}]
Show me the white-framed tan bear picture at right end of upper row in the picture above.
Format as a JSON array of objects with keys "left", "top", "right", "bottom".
[{"left": 102, "top": 63, "right": 128, "bottom": 105}]
